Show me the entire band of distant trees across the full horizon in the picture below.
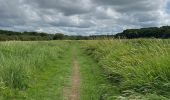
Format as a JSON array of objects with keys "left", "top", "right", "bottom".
[{"left": 0, "top": 26, "right": 170, "bottom": 41}]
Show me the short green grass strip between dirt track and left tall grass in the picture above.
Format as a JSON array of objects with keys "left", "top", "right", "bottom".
[{"left": 27, "top": 46, "right": 72, "bottom": 100}]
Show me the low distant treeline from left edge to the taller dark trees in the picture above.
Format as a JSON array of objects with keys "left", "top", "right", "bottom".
[{"left": 0, "top": 30, "right": 114, "bottom": 41}]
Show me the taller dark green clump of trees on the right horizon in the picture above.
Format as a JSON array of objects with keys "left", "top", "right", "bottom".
[{"left": 115, "top": 26, "right": 170, "bottom": 39}]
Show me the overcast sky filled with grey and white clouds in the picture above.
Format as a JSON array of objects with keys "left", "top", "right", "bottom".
[{"left": 0, "top": 0, "right": 170, "bottom": 35}]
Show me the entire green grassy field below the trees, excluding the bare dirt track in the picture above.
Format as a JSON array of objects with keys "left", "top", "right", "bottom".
[{"left": 0, "top": 39, "right": 170, "bottom": 100}]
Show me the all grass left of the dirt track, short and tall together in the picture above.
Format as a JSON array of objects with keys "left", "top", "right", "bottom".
[{"left": 0, "top": 41, "right": 71, "bottom": 100}]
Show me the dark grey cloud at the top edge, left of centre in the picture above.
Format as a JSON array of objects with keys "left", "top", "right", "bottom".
[{"left": 26, "top": 0, "right": 92, "bottom": 16}]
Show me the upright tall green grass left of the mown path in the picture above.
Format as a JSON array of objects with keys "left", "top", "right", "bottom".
[{"left": 0, "top": 41, "right": 69, "bottom": 97}]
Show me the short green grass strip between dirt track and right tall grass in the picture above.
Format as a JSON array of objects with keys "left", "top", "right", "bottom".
[{"left": 76, "top": 44, "right": 119, "bottom": 100}]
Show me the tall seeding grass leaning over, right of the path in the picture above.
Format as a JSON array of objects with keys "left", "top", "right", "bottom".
[{"left": 84, "top": 39, "right": 170, "bottom": 97}]
